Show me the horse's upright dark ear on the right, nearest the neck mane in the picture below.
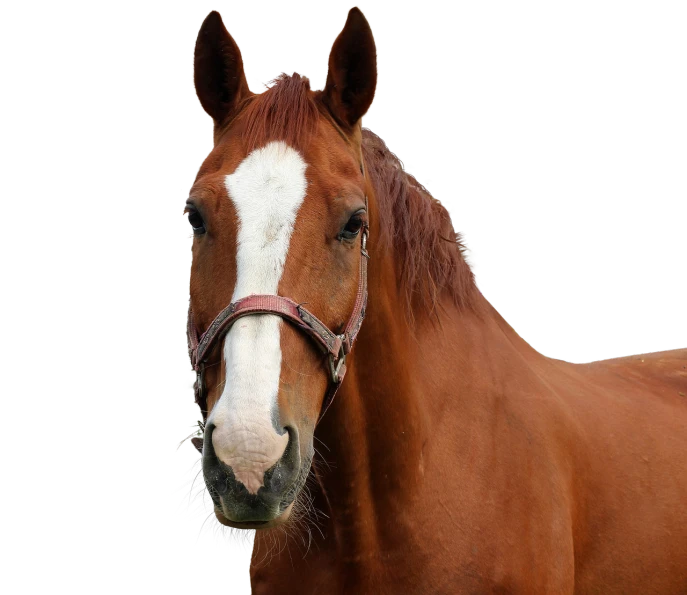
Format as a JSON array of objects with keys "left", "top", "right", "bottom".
[{"left": 322, "top": 5, "right": 379, "bottom": 127}]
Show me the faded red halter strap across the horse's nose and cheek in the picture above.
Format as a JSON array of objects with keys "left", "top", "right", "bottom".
[{"left": 186, "top": 217, "right": 370, "bottom": 422}]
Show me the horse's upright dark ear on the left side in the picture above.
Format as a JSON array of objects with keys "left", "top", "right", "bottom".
[{"left": 192, "top": 10, "right": 252, "bottom": 123}]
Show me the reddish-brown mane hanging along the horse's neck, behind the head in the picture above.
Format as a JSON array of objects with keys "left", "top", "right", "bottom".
[{"left": 363, "top": 127, "right": 480, "bottom": 325}]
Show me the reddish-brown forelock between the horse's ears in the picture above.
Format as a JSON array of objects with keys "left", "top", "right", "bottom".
[{"left": 243, "top": 72, "right": 319, "bottom": 153}]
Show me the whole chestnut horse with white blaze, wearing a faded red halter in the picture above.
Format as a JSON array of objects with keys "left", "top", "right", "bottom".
[{"left": 184, "top": 6, "right": 687, "bottom": 595}]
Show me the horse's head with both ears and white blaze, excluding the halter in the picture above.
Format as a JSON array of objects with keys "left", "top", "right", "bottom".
[{"left": 185, "top": 8, "right": 377, "bottom": 528}]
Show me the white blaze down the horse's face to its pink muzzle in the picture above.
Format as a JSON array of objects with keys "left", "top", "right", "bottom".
[{"left": 208, "top": 142, "right": 307, "bottom": 493}]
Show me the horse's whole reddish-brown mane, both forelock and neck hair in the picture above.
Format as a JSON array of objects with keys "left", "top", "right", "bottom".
[{"left": 242, "top": 72, "right": 479, "bottom": 326}]
